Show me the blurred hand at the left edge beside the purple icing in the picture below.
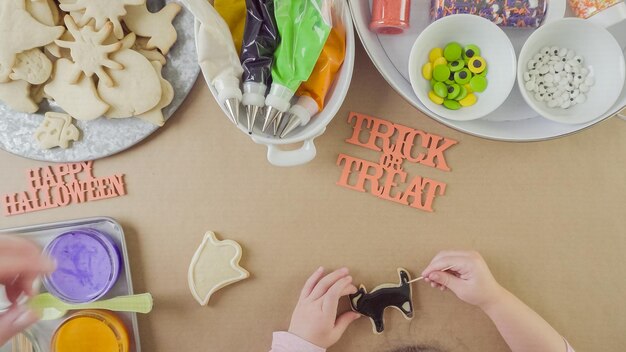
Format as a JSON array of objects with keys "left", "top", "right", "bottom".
[{"left": 0, "top": 236, "right": 54, "bottom": 346}]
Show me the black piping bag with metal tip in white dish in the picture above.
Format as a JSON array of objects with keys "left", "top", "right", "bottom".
[{"left": 241, "top": 0, "right": 280, "bottom": 134}]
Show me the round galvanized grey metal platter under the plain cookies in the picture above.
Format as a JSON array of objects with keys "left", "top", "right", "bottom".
[{"left": 0, "top": 0, "right": 200, "bottom": 162}]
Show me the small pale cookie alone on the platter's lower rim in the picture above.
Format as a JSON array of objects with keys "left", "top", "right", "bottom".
[{"left": 35, "top": 112, "right": 80, "bottom": 149}]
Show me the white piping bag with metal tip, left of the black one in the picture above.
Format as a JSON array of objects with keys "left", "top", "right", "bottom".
[{"left": 183, "top": 0, "right": 243, "bottom": 125}]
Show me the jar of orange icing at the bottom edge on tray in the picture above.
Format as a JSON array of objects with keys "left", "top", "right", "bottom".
[{"left": 51, "top": 310, "right": 129, "bottom": 352}]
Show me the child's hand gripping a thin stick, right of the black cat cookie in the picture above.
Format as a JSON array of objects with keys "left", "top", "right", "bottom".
[{"left": 422, "top": 251, "right": 505, "bottom": 308}]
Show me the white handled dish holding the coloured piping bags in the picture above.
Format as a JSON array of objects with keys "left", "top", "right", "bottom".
[{"left": 201, "top": 1, "right": 355, "bottom": 166}]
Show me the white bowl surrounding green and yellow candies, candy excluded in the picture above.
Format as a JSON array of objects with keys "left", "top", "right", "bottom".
[{"left": 409, "top": 15, "right": 517, "bottom": 121}]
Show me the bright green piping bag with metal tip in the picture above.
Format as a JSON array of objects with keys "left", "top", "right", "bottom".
[{"left": 263, "top": 0, "right": 332, "bottom": 131}]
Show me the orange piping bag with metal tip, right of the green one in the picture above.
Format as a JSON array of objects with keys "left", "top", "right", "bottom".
[{"left": 280, "top": 1, "right": 346, "bottom": 138}]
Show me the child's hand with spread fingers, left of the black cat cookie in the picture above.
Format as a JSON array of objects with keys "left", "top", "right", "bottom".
[{"left": 289, "top": 268, "right": 361, "bottom": 348}]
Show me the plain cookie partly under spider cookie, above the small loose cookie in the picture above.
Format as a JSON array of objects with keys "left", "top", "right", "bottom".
[{"left": 44, "top": 59, "right": 109, "bottom": 121}]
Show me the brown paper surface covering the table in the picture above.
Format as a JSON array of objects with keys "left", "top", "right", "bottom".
[{"left": 0, "top": 42, "right": 626, "bottom": 352}]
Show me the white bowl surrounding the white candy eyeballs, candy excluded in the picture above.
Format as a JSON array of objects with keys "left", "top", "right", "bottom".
[{"left": 517, "top": 18, "right": 626, "bottom": 124}]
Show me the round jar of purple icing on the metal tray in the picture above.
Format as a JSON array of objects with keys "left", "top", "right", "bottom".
[{"left": 43, "top": 229, "right": 121, "bottom": 303}]
